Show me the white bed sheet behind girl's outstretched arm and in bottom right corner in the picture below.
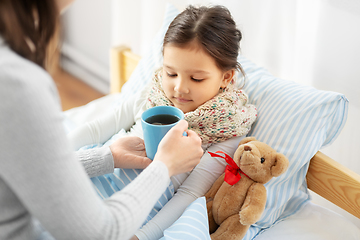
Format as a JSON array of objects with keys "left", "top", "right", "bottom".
[{"left": 64, "top": 94, "right": 360, "bottom": 240}]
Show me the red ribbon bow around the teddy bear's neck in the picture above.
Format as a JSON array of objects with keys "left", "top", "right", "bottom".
[{"left": 208, "top": 151, "right": 249, "bottom": 185}]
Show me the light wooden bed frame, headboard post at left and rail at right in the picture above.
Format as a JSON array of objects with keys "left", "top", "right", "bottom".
[{"left": 110, "top": 47, "right": 360, "bottom": 219}]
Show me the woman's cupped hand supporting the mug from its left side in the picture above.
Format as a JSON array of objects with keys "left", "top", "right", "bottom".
[{"left": 110, "top": 136, "right": 152, "bottom": 169}]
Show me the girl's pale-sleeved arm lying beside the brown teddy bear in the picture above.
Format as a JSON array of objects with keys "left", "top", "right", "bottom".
[{"left": 136, "top": 137, "right": 244, "bottom": 240}]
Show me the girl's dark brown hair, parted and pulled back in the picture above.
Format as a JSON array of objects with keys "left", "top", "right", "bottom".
[{"left": 163, "top": 6, "right": 245, "bottom": 76}]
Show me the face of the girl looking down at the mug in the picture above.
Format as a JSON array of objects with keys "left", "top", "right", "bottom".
[{"left": 162, "top": 42, "right": 235, "bottom": 113}]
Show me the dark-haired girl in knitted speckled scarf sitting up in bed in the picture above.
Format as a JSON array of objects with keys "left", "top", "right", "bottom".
[{"left": 69, "top": 6, "right": 257, "bottom": 240}]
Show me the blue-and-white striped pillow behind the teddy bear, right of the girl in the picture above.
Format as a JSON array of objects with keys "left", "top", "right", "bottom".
[{"left": 239, "top": 56, "right": 348, "bottom": 239}]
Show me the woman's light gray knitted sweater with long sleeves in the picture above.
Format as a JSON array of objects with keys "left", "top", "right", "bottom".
[{"left": 0, "top": 37, "right": 170, "bottom": 240}]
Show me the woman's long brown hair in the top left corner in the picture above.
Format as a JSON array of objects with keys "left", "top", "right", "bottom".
[{"left": 0, "top": 0, "right": 59, "bottom": 69}]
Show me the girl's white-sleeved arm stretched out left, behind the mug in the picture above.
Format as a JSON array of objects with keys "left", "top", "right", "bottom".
[{"left": 68, "top": 88, "right": 146, "bottom": 150}]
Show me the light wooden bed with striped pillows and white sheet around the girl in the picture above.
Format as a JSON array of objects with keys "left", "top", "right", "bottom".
[{"left": 64, "top": 4, "right": 360, "bottom": 240}]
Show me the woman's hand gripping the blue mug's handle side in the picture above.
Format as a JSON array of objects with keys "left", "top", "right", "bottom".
[{"left": 154, "top": 120, "right": 204, "bottom": 176}]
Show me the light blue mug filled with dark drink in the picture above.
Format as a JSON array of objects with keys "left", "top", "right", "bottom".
[{"left": 141, "top": 106, "right": 184, "bottom": 160}]
